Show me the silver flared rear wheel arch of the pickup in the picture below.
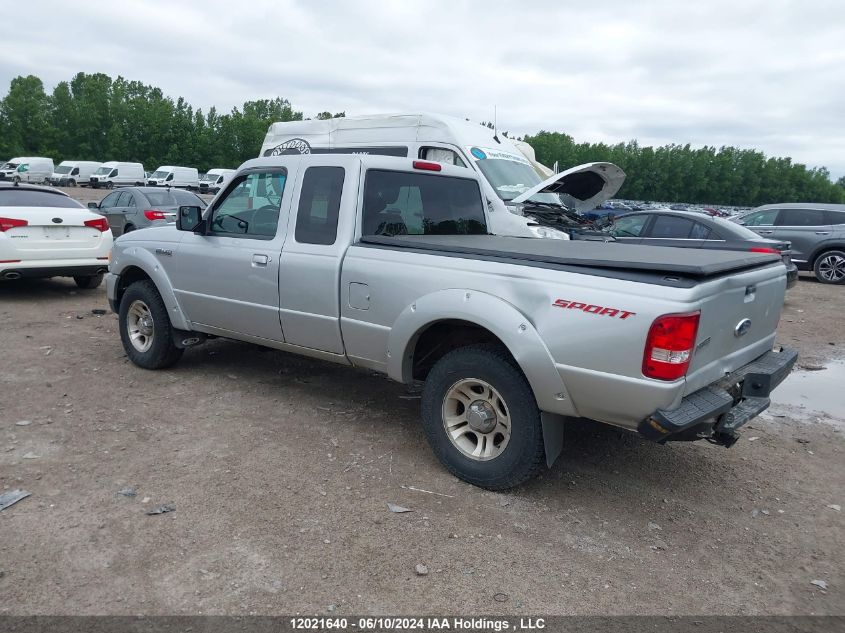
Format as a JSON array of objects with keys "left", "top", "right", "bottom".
[{"left": 387, "top": 288, "right": 576, "bottom": 415}]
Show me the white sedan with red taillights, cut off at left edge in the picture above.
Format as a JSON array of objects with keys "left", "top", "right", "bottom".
[{"left": 0, "top": 183, "right": 113, "bottom": 288}]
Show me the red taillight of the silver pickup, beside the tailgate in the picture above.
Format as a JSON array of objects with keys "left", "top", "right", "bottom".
[{"left": 643, "top": 312, "right": 701, "bottom": 380}]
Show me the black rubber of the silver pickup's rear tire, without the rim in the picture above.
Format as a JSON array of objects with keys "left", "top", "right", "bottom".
[{"left": 422, "top": 345, "right": 545, "bottom": 490}]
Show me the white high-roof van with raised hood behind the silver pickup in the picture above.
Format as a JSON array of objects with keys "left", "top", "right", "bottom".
[{"left": 260, "top": 114, "right": 625, "bottom": 239}]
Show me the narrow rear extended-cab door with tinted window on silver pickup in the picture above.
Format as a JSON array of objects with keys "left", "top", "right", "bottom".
[{"left": 279, "top": 155, "right": 360, "bottom": 354}]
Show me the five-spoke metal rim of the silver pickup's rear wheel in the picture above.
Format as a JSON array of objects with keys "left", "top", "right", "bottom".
[{"left": 442, "top": 378, "right": 511, "bottom": 462}]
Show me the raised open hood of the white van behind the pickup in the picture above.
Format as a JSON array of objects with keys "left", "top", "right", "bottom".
[{"left": 509, "top": 163, "right": 625, "bottom": 213}]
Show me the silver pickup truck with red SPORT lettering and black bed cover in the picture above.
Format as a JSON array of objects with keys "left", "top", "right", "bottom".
[{"left": 107, "top": 154, "right": 796, "bottom": 489}]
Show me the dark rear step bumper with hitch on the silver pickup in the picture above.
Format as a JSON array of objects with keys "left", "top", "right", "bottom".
[{"left": 637, "top": 348, "right": 798, "bottom": 446}]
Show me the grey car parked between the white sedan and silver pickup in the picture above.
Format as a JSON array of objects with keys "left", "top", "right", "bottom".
[{"left": 88, "top": 187, "right": 206, "bottom": 237}]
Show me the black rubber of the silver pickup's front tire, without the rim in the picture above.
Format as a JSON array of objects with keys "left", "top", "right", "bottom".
[{"left": 118, "top": 280, "right": 184, "bottom": 369}]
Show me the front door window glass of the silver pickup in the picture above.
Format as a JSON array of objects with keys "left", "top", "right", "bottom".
[{"left": 209, "top": 170, "right": 287, "bottom": 239}]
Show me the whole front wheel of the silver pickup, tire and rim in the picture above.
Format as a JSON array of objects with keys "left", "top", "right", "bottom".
[{"left": 118, "top": 280, "right": 184, "bottom": 369}]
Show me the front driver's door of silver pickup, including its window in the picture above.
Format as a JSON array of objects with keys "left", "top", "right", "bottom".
[{"left": 167, "top": 167, "right": 296, "bottom": 342}]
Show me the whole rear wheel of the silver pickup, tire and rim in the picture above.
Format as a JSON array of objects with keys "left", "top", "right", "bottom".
[{"left": 422, "top": 345, "right": 545, "bottom": 490}]
